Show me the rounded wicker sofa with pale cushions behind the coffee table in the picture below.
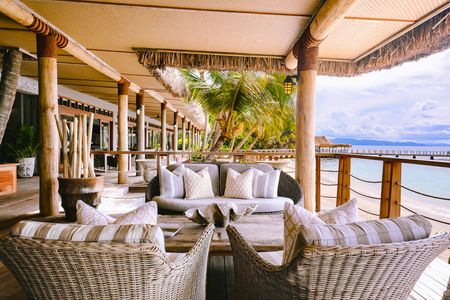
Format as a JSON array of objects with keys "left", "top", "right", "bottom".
[{"left": 145, "top": 163, "right": 303, "bottom": 214}]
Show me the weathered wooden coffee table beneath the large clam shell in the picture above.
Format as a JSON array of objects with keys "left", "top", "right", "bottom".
[{"left": 158, "top": 214, "right": 283, "bottom": 256}]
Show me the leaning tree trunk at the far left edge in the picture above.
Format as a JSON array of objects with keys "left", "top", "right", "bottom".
[{"left": 0, "top": 49, "right": 22, "bottom": 144}]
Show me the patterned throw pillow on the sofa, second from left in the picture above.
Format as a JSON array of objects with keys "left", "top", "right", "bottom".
[{"left": 184, "top": 168, "right": 214, "bottom": 199}]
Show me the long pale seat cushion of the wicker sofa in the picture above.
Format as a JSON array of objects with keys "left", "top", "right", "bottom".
[{"left": 152, "top": 196, "right": 294, "bottom": 213}]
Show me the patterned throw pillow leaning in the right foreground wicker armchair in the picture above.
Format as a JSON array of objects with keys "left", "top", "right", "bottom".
[{"left": 283, "top": 199, "right": 358, "bottom": 262}]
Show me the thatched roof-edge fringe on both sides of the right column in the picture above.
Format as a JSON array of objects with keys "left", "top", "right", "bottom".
[{"left": 135, "top": 8, "right": 450, "bottom": 76}]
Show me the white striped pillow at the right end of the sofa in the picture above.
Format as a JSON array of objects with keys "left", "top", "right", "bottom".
[{"left": 252, "top": 168, "right": 281, "bottom": 198}]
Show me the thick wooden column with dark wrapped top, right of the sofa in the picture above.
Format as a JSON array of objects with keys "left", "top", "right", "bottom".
[{"left": 295, "top": 37, "right": 319, "bottom": 212}]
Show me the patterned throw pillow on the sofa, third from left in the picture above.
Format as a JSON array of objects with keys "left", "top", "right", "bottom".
[{"left": 223, "top": 169, "right": 253, "bottom": 199}]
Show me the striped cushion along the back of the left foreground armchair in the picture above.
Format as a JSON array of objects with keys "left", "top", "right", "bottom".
[{"left": 11, "top": 221, "right": 165, "bottom": 251}]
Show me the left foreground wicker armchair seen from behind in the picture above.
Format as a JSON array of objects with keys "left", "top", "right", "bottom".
[{"left": 0, "top": 225, "right": 214, "bottom": 299}]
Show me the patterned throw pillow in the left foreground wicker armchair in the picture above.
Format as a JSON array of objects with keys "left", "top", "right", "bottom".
[{"left": 77, "top": 200, "right": 158, "bottom": 225}]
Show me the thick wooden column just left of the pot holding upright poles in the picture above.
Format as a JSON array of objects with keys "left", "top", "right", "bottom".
[{"left": 36, "top": 35, "right": 60, "bottom": 216}]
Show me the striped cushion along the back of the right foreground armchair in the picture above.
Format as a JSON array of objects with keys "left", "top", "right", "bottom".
[{"left": 286, "top": 215, "right": 431, "bottom": 261}]
